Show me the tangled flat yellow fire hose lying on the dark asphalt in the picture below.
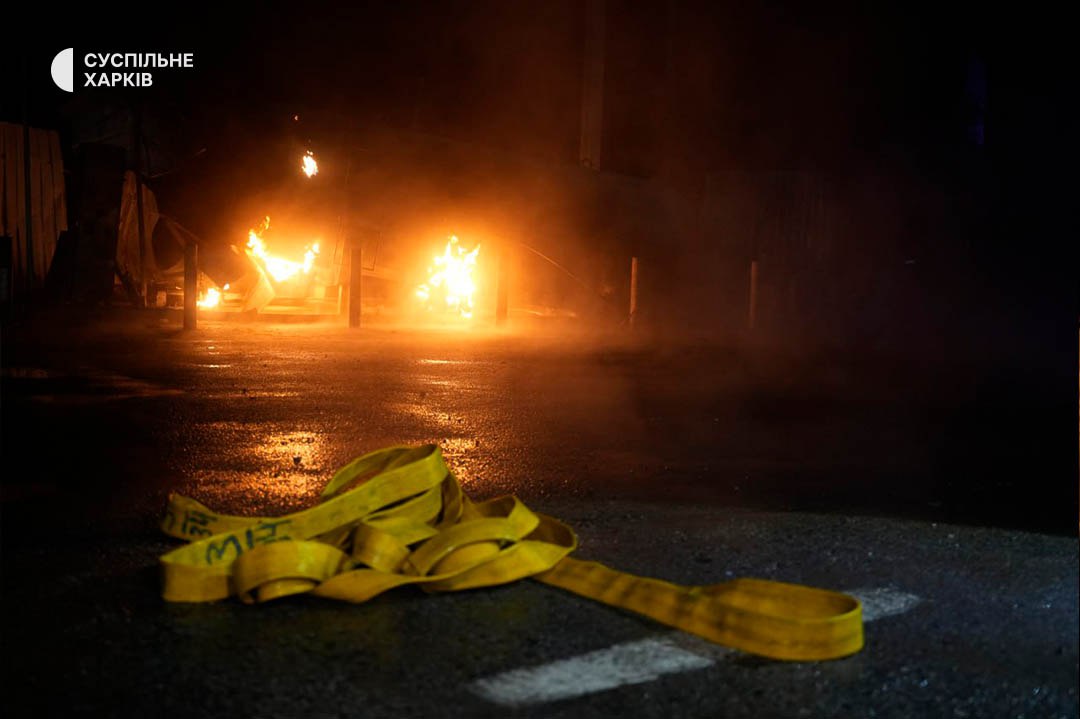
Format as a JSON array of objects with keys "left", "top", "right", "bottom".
[{"left": 161, "top": 445, "right": 863, "bottom": 661}]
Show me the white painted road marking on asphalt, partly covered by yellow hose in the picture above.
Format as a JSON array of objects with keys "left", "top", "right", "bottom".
[{"left": 469, "top": 587, "right": 921, "bottom": 706}]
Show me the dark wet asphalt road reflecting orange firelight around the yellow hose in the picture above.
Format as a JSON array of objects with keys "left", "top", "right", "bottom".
[{"left": 0, "top": 314, "right": 1080, "bottom": 717}]
